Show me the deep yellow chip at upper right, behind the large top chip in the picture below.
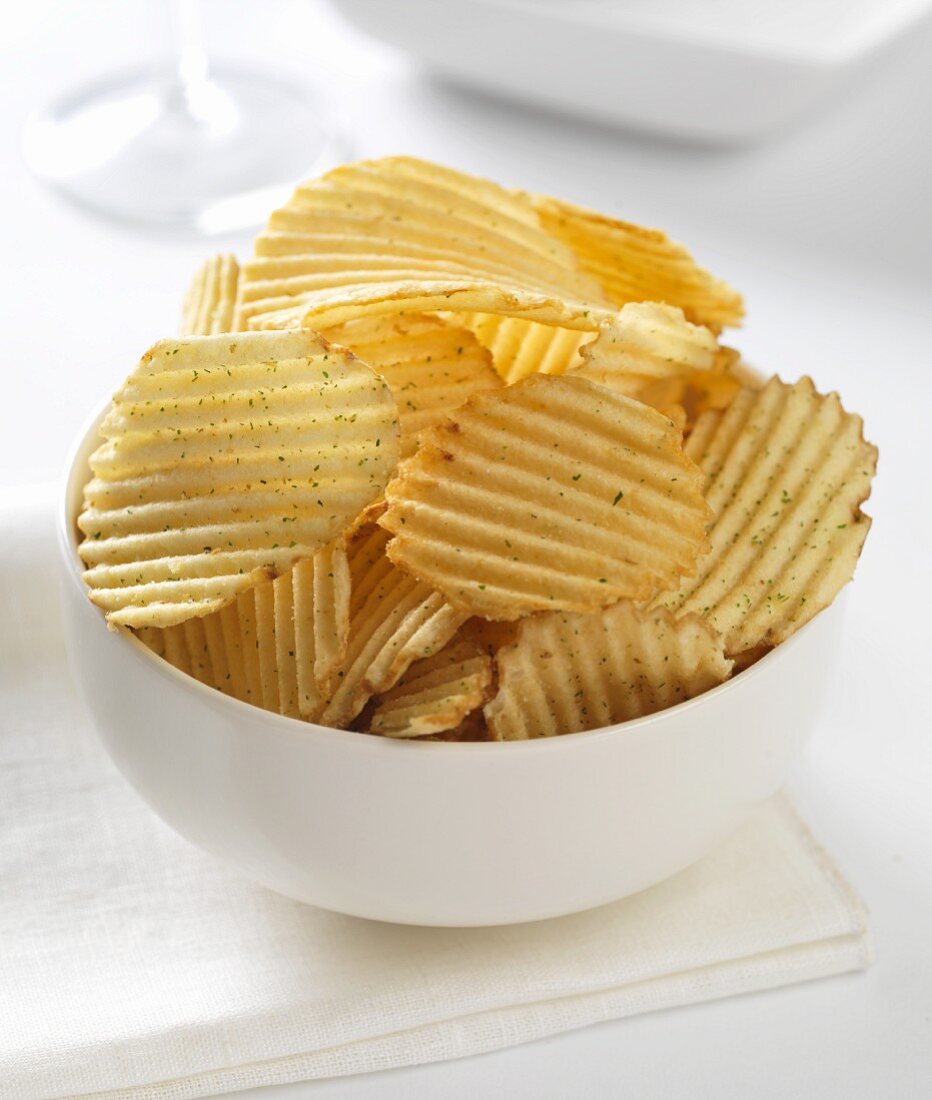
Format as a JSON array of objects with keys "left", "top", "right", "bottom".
[{"left": 530, "top": 195, "right": 744, "bottom": 332}]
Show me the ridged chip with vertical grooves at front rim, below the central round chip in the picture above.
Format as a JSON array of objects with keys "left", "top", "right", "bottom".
[{"left": 484, "top": 601, "right": 732, "bottom": 741}]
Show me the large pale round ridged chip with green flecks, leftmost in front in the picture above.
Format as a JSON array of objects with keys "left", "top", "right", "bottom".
[{"left": 78, "top": 332, "right": 398, "bottom": 627}]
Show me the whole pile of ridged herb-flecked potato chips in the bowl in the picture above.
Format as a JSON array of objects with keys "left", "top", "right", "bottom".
[{"left": 78, "top": 157, "right": 877, "bottom": 740}]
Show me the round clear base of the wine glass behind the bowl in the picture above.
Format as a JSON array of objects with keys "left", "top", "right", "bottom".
[{"left": 23, "top": 66, "right": 349, "bottom": 234}]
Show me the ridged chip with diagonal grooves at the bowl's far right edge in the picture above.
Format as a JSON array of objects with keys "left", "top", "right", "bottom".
[{"left": 654, "top": 377, "right": 877, "bottom": 655}]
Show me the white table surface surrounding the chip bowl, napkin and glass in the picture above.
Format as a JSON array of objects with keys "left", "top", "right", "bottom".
[{"left": 0, "top": 0, "right": 932, "bottom": 1100}]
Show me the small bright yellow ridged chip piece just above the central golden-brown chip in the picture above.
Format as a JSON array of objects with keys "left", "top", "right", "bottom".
[{"left": 460, "top": 314, "right": 610, "bottom": 385}]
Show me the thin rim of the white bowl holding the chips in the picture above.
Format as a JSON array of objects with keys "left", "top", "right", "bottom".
[{"left": 55, "top": 397, "right": 844, "bottom": 756}]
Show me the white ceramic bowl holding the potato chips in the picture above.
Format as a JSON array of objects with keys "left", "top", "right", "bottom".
[{"left": 58, "top": 409, "right": 842, "bottom": 925}]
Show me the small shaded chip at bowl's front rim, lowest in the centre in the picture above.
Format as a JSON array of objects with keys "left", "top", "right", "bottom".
[{"left": 369, "top": 638, "right": 492, "bottom": 737}]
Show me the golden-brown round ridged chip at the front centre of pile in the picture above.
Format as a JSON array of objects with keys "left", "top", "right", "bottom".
[{"left": 380, "top": 375, "right": 711, "bottom": 619}]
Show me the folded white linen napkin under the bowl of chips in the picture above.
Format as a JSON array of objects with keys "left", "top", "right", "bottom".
[{"left": 0, "top": 490, "right": 871, "bottom": 1100}]
